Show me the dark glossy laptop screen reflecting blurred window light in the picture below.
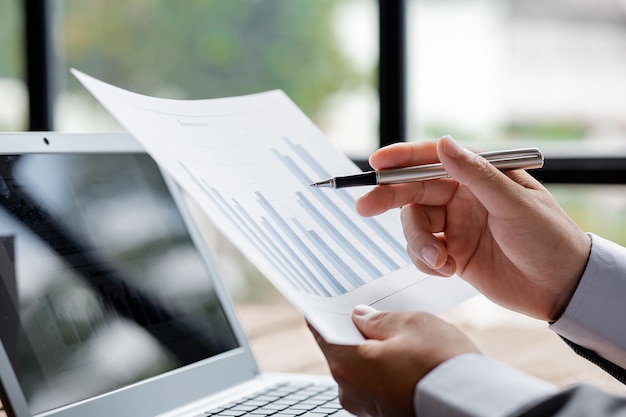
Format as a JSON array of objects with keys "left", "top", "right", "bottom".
[{"left": 0, "top": 153, "right": 238, "bottom": 413}]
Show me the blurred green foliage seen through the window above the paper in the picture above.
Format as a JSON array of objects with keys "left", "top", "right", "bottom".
[{"left": 59, "top": 0, "right": 366, "bottom": 114}]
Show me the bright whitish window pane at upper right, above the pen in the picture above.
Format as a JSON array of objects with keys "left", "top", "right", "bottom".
[{"left": 408, "top": 0, "right": 626, "bottom": 153}]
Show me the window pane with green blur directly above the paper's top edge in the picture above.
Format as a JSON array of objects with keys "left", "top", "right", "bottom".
[{"left": 56, "top": 0, "right": 378, "bottom": 155}]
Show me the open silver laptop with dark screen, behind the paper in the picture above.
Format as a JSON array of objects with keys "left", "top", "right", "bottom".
[{"left": 0, "top": 132, "right": 350, "bottom": 417}]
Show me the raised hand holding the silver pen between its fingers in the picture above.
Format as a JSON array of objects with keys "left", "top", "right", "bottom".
[{"left": 357, "top": 137, "right": 590, "bottom": 320}]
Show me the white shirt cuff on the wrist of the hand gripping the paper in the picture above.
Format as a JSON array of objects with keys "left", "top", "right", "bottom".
[{"left": 414, "top": 353, "right": 557, "bottom": 417}]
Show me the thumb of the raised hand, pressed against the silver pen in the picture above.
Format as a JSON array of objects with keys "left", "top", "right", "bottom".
[{"left": 437, "top": 136, "right": 520, "bottom": 214}]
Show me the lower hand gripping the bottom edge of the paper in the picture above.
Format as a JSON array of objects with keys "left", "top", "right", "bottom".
[{"left": 310, "top": 306, "right": 478, "bottom": 417}]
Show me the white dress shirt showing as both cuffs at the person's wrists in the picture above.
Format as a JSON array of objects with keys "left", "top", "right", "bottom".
[{"left": 414, "top": 235, "right": 626, "bottom": 417}]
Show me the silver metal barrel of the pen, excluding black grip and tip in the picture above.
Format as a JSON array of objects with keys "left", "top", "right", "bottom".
[{"left": 376, "top": 148, "right": 544, "bottom": 184}]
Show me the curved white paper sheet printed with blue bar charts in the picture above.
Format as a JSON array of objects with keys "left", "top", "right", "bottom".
[{"left": 73, "top": 71, "right": 474, "bottom": 344}]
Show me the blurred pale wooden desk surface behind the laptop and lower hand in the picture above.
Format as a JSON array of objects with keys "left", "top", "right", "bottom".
[{"left": 0, "top": 302, "right": 626, "bottom": 417}]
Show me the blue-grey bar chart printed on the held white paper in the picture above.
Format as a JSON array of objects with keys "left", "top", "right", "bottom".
[{"left": 179, "top": 137, "right": 410, "bottom": 297}]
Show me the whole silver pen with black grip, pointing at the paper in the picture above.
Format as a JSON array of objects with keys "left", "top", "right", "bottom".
[{"left": 311, "top": 148, "right": 543, "bottom": 188}]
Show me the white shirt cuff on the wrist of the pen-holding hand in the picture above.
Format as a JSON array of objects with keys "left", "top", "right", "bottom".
[{"left": 550, "top": 235, "right": 626, "bottom": 368}]
